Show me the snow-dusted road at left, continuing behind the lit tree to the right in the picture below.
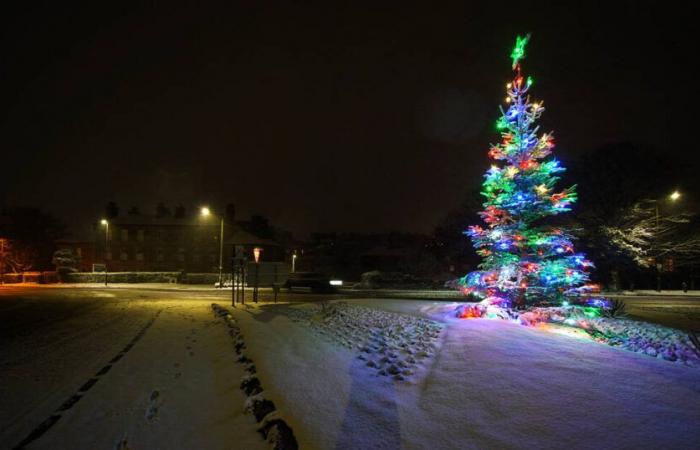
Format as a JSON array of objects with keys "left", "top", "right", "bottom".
[{"left": 0, "top": 286, "right": 700, "bottom": 449}]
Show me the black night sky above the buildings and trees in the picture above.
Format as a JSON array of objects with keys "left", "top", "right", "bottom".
[{"left": 0, "top": 1, "right": 698, "bottom": 235}]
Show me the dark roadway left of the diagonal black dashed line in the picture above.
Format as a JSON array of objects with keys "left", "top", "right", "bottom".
[{"left": 0, "top": 292, "right": 156, "bottom": 447}]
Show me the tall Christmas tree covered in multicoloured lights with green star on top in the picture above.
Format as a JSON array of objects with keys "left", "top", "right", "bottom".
[{"left": 461, "top": 35, "right": 596, "bottom": 315}]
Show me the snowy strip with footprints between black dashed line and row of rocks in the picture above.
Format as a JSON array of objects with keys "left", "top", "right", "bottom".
[{"left": 17, "top": 300, "right": 267, "bottom": 449}]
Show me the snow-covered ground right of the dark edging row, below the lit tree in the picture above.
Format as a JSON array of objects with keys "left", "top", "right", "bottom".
[{"left": 234, "top": 299, "right": 700, "bottom": 449}]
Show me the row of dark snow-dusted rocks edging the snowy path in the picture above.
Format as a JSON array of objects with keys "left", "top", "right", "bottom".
[{"left": 211, "top": 303, "right": 299, "bottom": 450}]
